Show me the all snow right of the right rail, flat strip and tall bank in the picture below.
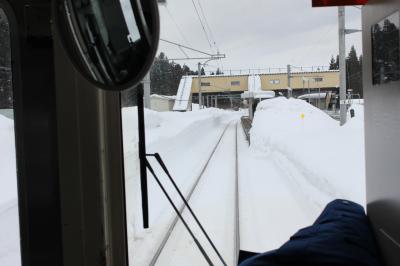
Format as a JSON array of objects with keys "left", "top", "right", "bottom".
[{"left": 239, "top": 98, "right": 365, "bottom": 252}]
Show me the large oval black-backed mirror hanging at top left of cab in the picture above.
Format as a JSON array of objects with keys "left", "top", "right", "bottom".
[{"left": 54, "top": 0, "right": 160, "bottom": 91}]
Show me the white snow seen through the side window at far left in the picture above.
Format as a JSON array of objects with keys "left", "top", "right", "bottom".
[{"left": 0, "top": 115, "right": 21, "bottom": 266}]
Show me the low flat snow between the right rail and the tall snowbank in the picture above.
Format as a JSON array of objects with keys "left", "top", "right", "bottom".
[{"left": 238, "top": 126, "right": 313, "bottom": 252}]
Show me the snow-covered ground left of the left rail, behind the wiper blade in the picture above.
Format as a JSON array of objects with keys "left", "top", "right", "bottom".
[{"left": 123, "top": 108, "right": 241, "bottom": 265}]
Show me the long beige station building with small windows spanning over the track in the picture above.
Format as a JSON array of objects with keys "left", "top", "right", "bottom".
[{"left": 173, "top": 70, "right": 340, "bottom": 108}]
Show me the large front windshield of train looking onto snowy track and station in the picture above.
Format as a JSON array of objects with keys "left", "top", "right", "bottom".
[{"left": 122, "top": 0, "right": 365, "bottom": 265}]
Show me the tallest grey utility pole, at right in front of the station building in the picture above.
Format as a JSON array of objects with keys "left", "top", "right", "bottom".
[{"left": 338, "top": 6, "right": 347, "bottom": 125}]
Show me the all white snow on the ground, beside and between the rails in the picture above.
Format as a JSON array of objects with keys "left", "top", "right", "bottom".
[{"left": 0, "top": 98, "right": 365, "bottom": 266}]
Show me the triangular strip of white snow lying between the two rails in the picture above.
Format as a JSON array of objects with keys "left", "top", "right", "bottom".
[{"left": 156, "top": 124, "right": 236, "bottom": 266}]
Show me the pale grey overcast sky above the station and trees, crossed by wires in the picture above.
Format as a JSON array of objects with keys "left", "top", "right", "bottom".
[{"left": 159, "top": 0, "right": 362, "bottom": 70}]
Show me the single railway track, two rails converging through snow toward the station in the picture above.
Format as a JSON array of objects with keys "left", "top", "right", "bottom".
[{"left": 149, "top": 123, "right": 240, "bottom": 265}]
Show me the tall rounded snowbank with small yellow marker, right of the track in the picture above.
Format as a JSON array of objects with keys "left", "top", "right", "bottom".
[{"left": 251, "top": 97, "right": 365, "bottom": 209}]
